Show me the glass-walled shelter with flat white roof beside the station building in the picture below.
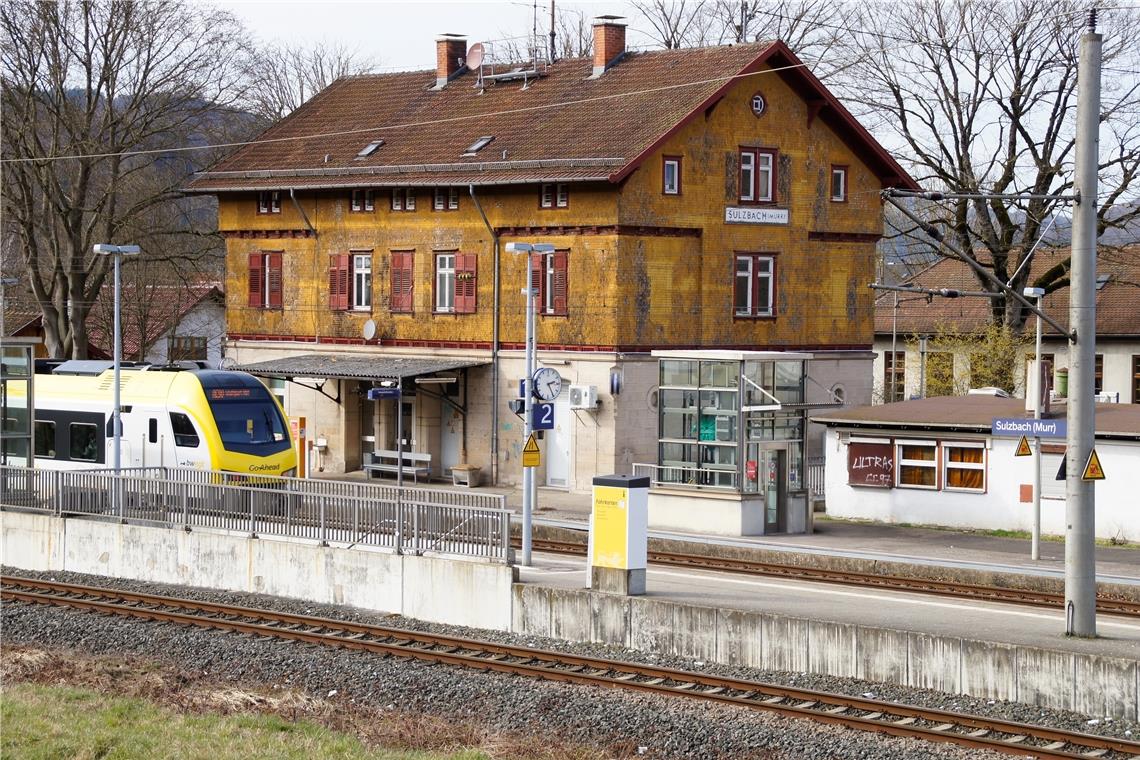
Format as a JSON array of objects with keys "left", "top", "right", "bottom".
[{"left": 653, "top": 351, "right": 812, "bottom": 533}]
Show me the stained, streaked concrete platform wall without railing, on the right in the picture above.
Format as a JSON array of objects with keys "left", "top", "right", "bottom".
[{"left": 512, "top": 583, "right": 1140, "bottom": 720}]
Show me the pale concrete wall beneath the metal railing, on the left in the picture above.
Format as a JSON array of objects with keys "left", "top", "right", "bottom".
[{"left": 2, "top": 512, "right": 514, "bottom": 630}]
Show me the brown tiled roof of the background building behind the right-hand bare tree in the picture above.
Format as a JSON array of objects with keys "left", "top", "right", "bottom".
[{"left": 874, "top": 245, "right": 1140, "bottom": 336}]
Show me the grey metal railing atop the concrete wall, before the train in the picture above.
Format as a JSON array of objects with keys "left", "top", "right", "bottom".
[{"left": 0, "top": 466, "right": 512, "bottom": 563}]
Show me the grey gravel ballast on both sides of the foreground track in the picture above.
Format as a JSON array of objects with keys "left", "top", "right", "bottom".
[{"left": 2, "top": 569, "right": 1140, "bottom": 760}]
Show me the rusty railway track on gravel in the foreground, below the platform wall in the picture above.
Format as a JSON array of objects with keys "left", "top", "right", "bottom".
[{"left": 0, "top": 577, "right": 1140, "bottom": 759}]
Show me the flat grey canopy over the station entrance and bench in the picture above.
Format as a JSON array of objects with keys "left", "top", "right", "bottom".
[{"left": 229, "top": 353, "right": 490, "bottom": 381}]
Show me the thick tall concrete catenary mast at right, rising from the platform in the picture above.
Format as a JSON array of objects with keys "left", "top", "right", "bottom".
[{"left": 1065, "top": 10, "right": 1102, "bottom": 638}]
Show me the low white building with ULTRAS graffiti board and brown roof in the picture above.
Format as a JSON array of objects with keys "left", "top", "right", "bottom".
[{"left": 813, "top": 395, "right": 1140, "bottom": 541}]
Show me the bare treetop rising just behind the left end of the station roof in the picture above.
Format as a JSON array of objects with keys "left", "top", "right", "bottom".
[{"left": 245, "top": 42, "right": 377, "bottom": 123}]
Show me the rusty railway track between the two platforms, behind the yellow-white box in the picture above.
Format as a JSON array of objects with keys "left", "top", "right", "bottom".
[{"left": 532, "top": 539, "right": 1140, "bottom": 618}]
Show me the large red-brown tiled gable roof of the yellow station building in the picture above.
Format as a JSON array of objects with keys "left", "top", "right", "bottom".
[{"left": 188, "top": 42, "right": 915, "bottom": 193}]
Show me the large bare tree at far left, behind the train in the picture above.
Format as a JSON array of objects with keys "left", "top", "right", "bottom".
[{"left": 0, "top": 0, "right": 249, "bottom": 358}]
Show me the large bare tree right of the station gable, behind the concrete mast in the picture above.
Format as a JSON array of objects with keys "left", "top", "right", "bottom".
[{"left": 842, "top": 0, "right": 1140, "bottom": 329}]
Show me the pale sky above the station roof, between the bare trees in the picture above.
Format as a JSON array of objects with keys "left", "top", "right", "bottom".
[{"left": 215, "top": 0, "right": 649, "bottom": 71}]
